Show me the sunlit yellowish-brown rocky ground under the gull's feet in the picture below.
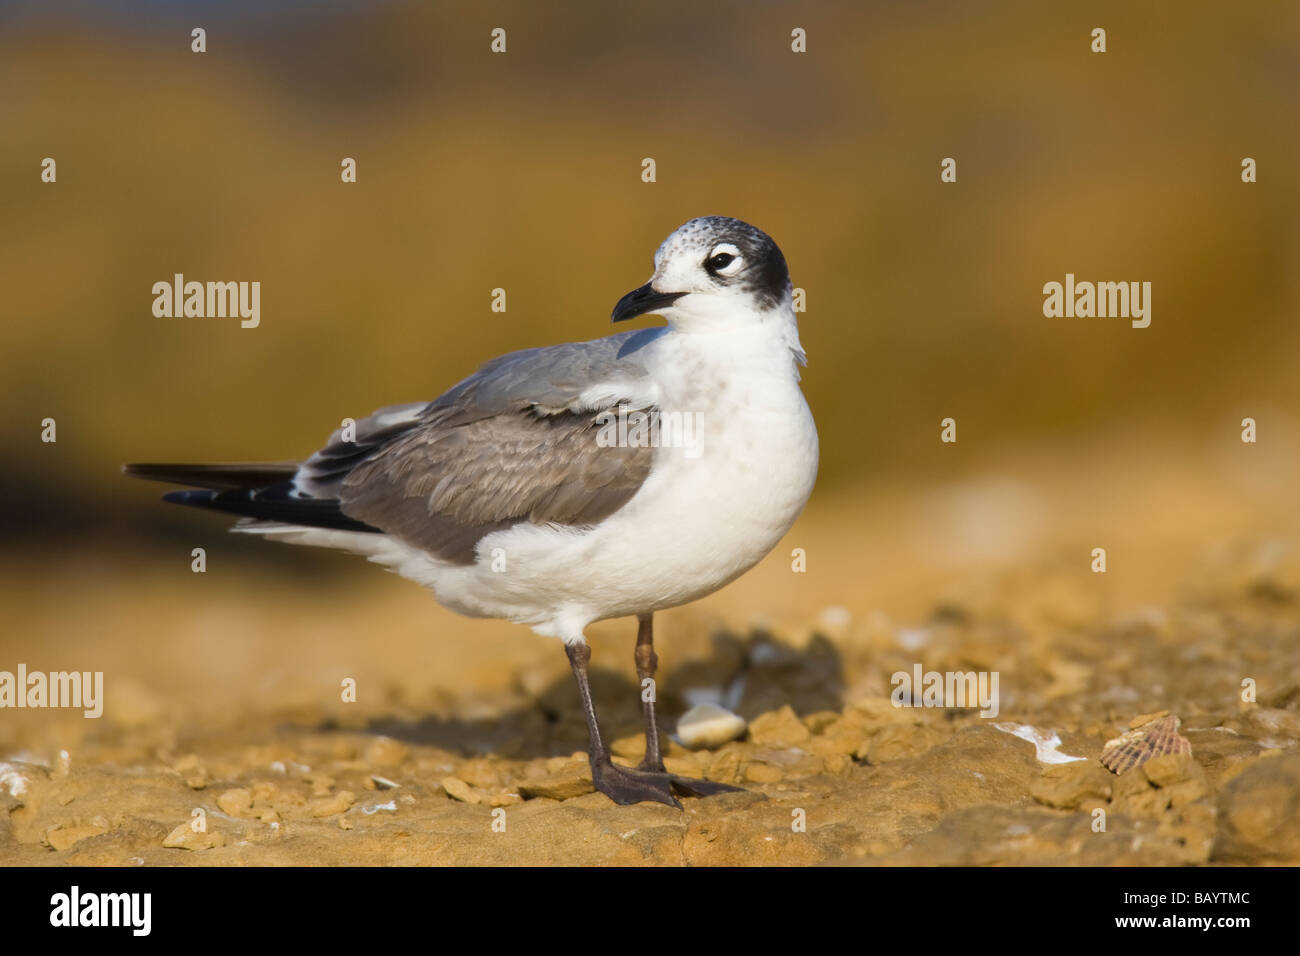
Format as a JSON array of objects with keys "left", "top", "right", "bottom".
[{"left": 0, "top": 546, "right": 1300, "bottom": 865}]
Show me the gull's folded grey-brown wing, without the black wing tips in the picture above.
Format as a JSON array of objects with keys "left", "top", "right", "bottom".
[{"left": 295, "top": 328, "right": 664, "bottom": 564}]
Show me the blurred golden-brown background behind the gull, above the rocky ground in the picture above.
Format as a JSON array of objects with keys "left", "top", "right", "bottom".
[{"left": 0, "top": 0, "right": 1300, "bottom": 744}]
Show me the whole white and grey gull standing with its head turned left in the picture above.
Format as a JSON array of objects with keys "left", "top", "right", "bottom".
[{"left": 124, "top": 216, "right": 818, "bottom": 808}]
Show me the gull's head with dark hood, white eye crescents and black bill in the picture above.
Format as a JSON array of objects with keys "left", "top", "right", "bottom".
[{"left": 614, "top": 216, "right": 790, "bottom": 329}]
